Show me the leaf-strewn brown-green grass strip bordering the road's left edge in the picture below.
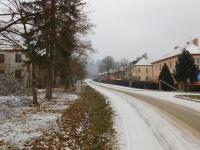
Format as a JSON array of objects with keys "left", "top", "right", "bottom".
[{"left": 62, "top": 86, "right": 115, "bottom": 150}]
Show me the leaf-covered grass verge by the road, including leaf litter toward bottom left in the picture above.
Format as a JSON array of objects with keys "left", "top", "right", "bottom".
[{"left": 31, "top": 86, "right": 116, "bottom": 150}]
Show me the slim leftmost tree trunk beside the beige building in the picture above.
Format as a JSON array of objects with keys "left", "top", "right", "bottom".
[{"left": 32, "top": 60, "right": 39, "bottom": 105}]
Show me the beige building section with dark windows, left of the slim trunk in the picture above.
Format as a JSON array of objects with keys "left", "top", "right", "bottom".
[{"left": 0, "top": 49, "right": 30, "bottom": 87}]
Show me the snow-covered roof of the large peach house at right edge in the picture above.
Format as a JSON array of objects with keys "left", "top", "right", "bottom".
[{"left": 153, "top": 43, "right": 200, "bottom": 63}]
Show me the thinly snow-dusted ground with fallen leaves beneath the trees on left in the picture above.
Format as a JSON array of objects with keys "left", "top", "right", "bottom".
[{"left": 0, "top": 91, "right": 78, "bottom": 149}]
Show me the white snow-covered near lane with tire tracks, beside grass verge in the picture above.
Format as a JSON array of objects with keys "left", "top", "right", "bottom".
[{"left": 88, "top": 81, "right": 200, "bottom": 150}]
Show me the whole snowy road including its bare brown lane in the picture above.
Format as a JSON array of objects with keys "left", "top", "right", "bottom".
[{"left": 88, "top": 82, "right": 200, "bottom": 150}]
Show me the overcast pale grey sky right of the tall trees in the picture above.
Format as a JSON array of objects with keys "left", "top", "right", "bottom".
[{"left": 88, "top": 0, "right": 200, "bottom": 60}]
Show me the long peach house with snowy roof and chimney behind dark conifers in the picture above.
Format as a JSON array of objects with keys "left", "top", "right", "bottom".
[{"left": 152, "top": 39, "right": 200, "bottom": 86}]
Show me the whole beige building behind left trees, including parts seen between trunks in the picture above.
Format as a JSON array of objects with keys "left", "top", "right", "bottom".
[{"left": 0, "top": 49, "right": 64, "bottom": 88}]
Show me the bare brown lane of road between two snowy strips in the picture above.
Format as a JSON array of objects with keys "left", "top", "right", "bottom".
[{"left": 100, "top": 82, "right": 200, "bottom": 139}]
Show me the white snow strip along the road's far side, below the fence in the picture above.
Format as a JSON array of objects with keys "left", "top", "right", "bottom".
[{"left": 91, "top": 81, "right": 200, "bottom": 112}]
